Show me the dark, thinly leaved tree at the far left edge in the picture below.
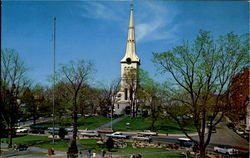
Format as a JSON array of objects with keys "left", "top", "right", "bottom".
[{"left": 0, "top": 49, "right": 30, "bottom": 147}]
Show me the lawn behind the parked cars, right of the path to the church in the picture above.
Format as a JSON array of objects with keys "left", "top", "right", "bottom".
[{"left": 113, "top": 117, "right": 196, "bottom": 134}]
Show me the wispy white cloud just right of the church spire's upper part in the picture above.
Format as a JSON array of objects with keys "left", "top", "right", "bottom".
[{"left": 135, "top": 3, "right": 178, "bottom": 42}]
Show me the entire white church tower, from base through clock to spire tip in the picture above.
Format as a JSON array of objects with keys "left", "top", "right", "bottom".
[{"left": 114, "top": 8, "right": 140, "bottom": 115}]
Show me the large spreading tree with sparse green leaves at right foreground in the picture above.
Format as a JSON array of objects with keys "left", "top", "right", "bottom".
[{"left": 153, "top": 31, "right": 249, "bottom": 158}]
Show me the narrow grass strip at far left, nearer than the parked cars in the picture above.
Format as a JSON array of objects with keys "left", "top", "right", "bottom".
[{"left": 2, "top": 135, "right": 51, "bottom": 144}]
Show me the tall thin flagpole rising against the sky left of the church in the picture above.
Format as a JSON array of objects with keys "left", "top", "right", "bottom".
[{"left": 53, "top": 17, "right": 56, "bottom": 144}]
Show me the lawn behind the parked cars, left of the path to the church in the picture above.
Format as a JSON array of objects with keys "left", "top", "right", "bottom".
[{"left": 36, "top": 116, "right": 110, "bottom": 129}]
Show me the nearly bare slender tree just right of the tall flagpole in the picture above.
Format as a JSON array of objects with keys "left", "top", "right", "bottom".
[{"left": 58, "top": 60, "right": 93, "bottom": 155}]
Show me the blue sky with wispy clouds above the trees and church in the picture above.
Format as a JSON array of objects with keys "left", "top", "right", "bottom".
[{"left": 1, "top": 0, "right": 249, "bottom": 85}]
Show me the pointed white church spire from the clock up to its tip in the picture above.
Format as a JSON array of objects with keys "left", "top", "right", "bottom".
[{"left": 121, "top": 7, "right": 140, "bottom": 64}]
